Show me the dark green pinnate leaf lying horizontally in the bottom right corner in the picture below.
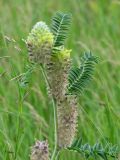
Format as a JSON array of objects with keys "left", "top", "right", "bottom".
[{"left": 67, "top": 138, "right": 118, "bottom": 160}]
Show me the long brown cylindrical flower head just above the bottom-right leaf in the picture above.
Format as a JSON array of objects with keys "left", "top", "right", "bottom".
[{"left": 57, "top": 96, "right": 78, "bottom": 148}]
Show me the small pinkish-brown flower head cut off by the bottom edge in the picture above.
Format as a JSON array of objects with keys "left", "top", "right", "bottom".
[{"left": 30, "top": 141, "right": 49, "bottom": 160}]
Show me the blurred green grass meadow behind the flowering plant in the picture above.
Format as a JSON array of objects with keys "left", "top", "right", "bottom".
[{"left": 0, "top": 0, "right": 120, "bottom": 160}]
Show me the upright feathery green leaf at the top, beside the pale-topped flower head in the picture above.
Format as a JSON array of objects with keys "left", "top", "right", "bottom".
[{"left": 51, "top": 12, "right": 71, "bottom": 47}]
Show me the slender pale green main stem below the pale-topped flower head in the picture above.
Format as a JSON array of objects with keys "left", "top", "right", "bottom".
[{"left": 40, "top": 64, "right": 59, "bottom": 160}]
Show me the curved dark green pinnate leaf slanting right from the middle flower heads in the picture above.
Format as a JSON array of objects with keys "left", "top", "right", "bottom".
[{"left": 67, "top": 52, "right": 97, "bottom": 95}]
